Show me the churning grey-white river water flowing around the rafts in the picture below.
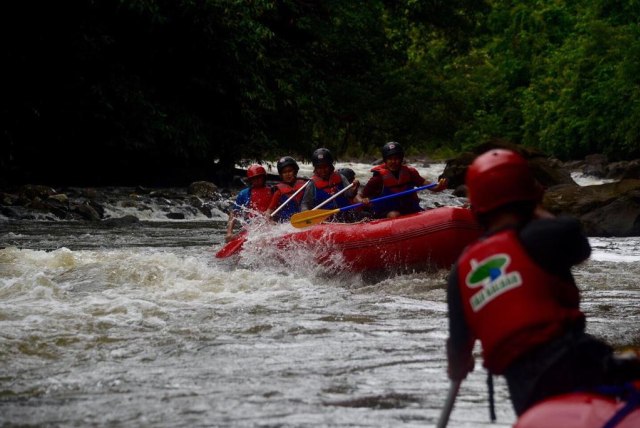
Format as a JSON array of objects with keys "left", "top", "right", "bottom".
[{"left": 0, "top": 164, "right": 640, "bottom": 427}]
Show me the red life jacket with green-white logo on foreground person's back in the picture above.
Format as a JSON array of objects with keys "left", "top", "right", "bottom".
[{"left": 458, "top": 229, "right": 584, "bottom": 374}]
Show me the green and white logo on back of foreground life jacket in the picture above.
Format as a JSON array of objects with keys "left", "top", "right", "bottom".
[{"left": 465, "top": 253, "right": 522, "bottom": 312}]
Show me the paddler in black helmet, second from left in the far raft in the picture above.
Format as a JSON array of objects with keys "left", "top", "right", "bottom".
[{"left": 265, "top": 156, "right": 307, "bottom": 222}]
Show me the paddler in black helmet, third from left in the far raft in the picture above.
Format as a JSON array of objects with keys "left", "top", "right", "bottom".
[{"left": 300, "top": 148, "right": 360, "bottom": 219}]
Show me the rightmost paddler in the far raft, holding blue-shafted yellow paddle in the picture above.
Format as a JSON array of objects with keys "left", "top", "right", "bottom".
[{"left": 358, "top": 141, "right": 447, "bottom": 218}]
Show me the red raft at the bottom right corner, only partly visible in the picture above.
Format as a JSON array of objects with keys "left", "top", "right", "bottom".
[{"left": 514, "top": 382, "right": 640, "bottom": 428}]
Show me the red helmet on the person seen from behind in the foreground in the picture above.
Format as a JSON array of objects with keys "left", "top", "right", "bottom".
[{"left": 465, "top": 149, "right": 542, "bottom": 214}]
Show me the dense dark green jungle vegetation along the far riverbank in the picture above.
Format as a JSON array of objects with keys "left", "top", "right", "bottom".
[{"left": 0, "top": 0, "right": 640, "bottom": 185}]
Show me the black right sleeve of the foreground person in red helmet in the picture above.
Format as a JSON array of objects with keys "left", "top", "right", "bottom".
[{"left": 520, "top": 217, "right": 591, "bottom": 275}]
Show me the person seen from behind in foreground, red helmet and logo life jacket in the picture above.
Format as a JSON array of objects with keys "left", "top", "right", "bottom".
[{"left": 447, "top": 149, "right": 640, "bottom": 416}]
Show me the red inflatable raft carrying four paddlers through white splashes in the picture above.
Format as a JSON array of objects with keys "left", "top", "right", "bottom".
[{"left": 216, "top": 207, "right": 481, "bottom": 272}]
